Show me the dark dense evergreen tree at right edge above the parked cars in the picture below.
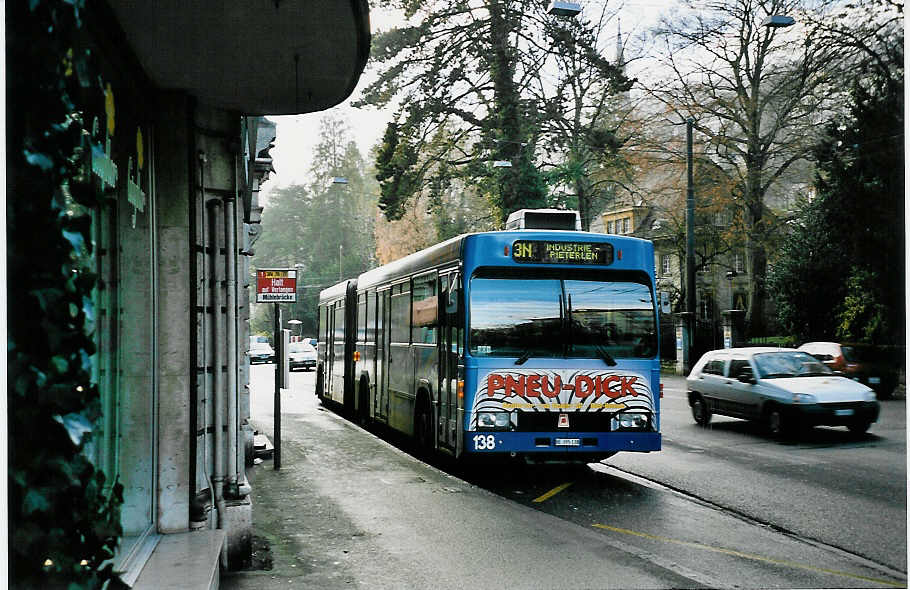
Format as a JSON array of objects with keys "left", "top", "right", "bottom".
[{"left": 772, "top": 20, "right": 906, "bottom": 344}]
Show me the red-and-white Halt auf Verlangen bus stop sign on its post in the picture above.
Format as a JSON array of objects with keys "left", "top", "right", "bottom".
[{"left": 256, "top": 268, "right": 297, "bottom": 471}]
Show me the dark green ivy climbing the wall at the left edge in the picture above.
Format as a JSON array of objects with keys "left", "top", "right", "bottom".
[{"left": 6, "top": 0, "right": 122, "bottom": 589}]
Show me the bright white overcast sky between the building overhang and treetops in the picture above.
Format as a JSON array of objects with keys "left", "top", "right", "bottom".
[{"left": 260, "top": 0, "right": 674, "bottom": 202}]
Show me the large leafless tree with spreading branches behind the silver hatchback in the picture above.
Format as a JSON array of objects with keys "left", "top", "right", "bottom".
[{"left": 646, "top": 0, "right": 844, "bottom": 334}]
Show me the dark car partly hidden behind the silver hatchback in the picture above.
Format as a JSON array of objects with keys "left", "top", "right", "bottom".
[{"left": 799, "top": 342, "right": 899, "bottom": 398}]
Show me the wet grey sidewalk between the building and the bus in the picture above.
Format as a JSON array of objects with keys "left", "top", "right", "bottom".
[{"left": 221, "top": 392, "right": 693, "bottom": 590}]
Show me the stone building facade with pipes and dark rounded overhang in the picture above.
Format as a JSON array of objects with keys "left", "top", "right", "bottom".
[{"left": 8, "top": 0, "right": 370, "bottom": 588}]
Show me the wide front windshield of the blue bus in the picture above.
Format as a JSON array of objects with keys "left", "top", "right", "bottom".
[{"left": 469, "top": 270, "right": 657, "bottom": 359}]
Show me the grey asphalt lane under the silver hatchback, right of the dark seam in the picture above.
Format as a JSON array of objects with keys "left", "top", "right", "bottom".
[{"left": 606, "top": 377, "right": 907, "bottom": 572}]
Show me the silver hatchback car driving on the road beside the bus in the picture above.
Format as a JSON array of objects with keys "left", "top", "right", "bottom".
[{"left": 686, "top": 348, "right": 879, "bottom": 436}]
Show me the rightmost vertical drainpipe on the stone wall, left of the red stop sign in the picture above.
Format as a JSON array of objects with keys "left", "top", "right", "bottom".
[{"left": 224, "top": 199, "right": 239, "bottom": 498}]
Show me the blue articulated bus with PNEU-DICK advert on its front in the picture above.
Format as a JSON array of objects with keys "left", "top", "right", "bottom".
[{"left": 316, "top": 229, "right": 661, "bottom": 461}]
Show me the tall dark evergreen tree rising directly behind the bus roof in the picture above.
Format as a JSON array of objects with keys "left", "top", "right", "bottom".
[{"left": 361, "top": 0, "right": 622, "bottom": 224}]
